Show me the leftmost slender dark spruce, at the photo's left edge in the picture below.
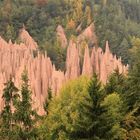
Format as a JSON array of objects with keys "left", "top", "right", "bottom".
[{"left": 0, "top": 77, "right": 18, "bottom": 140}]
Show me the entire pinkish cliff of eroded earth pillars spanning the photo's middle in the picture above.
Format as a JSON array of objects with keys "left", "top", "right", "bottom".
[{"left": 0, "top": 26, "right": 128, "bottom": 114}]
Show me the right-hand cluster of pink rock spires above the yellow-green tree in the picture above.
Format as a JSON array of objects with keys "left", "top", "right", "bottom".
[{"left": 66, "top": 41, "right": 128, "bottom": 84}]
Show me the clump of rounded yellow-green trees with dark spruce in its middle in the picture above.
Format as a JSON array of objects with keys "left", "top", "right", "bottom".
[{"left": 39, "top": 76, "right": 125, "bottom": 140}]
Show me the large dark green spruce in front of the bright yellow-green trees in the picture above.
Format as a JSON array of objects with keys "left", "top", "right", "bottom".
[{"left": 72, "top": 74, "right": 104, "bottom": 139}]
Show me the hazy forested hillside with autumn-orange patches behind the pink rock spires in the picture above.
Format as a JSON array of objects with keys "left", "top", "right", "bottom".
[{"left": 0, "top": 0, "right": 140, "bottom": 63}]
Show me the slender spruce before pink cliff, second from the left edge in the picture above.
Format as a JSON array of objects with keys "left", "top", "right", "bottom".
[{"left": 15, "top": 70, "right": 37, "bottom": 140}]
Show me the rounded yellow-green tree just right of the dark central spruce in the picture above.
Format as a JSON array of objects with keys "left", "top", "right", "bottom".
[{"left": 101, "top": 93, "right": 124, "bottom": 140}]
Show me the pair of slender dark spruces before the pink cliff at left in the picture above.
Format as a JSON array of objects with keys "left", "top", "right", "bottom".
[{"left": 0, "top": 71, "right": 39, "bottom": 140}]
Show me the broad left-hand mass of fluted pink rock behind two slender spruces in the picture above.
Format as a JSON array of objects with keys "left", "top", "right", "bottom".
[{"left": 0, "top": 35, "right": 65, "bottom": 114}]
